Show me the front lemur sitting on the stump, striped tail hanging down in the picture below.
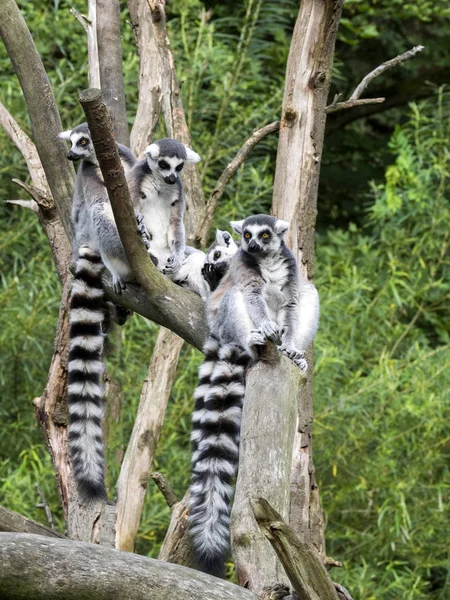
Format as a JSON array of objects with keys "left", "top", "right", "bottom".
[{"left": 189, "top": 215, "right": 319, "bottom": 575}]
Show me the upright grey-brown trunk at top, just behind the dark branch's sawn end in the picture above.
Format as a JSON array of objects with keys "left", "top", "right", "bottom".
[{"left": 96, "top": 0, "right": 130, "bottom": 146}]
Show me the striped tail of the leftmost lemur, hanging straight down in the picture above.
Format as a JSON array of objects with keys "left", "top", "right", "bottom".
[{"left": 68, "top": 246, "right": 106, "bottom": 500}]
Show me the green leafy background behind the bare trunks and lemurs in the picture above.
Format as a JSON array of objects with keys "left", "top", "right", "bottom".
[{"left": 0, "top": 0, "right": 450, "bottom": 600}]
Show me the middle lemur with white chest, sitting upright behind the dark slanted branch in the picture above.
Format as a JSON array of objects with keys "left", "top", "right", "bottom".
[{"left": 129, "top": 138, "right": 206, "bottom": 296}]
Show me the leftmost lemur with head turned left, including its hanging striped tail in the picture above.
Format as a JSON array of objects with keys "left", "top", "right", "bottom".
[{"left": 59, "top": 123, "right": 142, "bottom": 500}]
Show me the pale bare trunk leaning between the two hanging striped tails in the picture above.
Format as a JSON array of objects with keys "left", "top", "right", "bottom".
[{"left": 116, "top": 328, "right": 183, "bottom": 551}]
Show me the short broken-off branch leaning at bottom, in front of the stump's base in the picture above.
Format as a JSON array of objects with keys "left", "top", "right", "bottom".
[{"left": 250, "top": 498, "right": 338, "bottom": 600}]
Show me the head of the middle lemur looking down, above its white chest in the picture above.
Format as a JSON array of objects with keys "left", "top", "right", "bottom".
[{"left": 145, "top": 138, "right": 200, "bottom": 185}]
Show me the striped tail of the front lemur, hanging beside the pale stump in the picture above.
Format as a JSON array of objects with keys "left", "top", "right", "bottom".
[{"left": 189, "top": 337, "right": 250, "bottom": 576}]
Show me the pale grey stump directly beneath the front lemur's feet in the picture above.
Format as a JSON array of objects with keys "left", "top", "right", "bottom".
[{"left": 231, "top": 344, "right": 301, "bottom": 594}]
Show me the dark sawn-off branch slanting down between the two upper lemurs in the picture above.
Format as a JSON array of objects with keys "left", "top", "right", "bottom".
[{"left": 80, "top": 85, "right": 207, "bottom": 347}]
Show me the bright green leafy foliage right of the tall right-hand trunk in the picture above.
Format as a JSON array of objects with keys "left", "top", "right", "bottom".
[{"left": 315, "top": 92, "right": 450, "bottom": 599}]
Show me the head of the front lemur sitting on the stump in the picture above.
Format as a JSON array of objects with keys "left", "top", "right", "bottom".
[{"left": 231, "top": 215, "right": 289, "bottom": 254}]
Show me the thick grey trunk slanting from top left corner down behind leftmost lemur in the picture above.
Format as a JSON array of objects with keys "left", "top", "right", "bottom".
[{"left": 0, "top": 0, "right": 75, "bottom": 239}]
